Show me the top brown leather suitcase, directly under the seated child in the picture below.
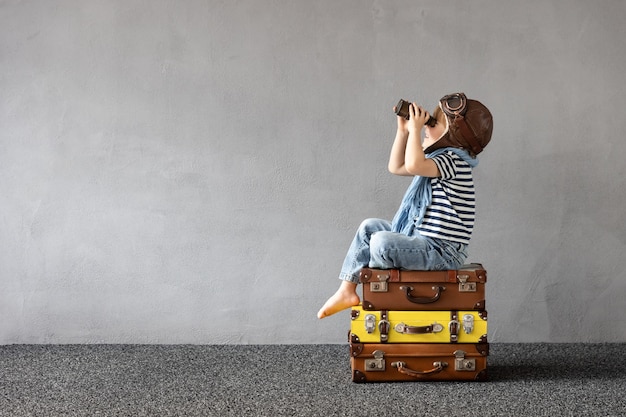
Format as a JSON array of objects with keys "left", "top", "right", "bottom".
[{"left": 360, "top": 263, "right": 487, "bottom": 311}]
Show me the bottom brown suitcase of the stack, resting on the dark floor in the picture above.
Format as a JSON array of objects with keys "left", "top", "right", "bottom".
[{"left": 350, "top": 343, "right": 489, "bottom": 382}]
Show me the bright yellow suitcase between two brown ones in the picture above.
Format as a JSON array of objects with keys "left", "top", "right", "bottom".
[{"left": 350, "top": 305, "right": 487, "bottom": 343}]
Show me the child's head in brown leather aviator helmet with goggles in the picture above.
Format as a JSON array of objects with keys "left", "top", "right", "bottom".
[{"left": 424, "top": 93, "right": 493, "bottom": 156}]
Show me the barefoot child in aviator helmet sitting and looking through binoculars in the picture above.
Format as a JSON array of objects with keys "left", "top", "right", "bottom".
[{"left": 317, "top": 93, "right": 493, "bottom": 319}]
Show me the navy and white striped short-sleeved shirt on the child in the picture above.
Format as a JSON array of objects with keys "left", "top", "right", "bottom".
[{"left": 417, "top": 152, "right": 476, "bottom": 244}]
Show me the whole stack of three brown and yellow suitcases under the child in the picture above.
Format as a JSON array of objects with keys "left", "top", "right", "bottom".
[{"left": 349, "top": 263, "right": 489, "bottom": 382}]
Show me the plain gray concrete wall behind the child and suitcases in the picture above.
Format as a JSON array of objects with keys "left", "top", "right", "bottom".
[{"left": 0, "top": 0, "right": 626, "bottom": 344}]
